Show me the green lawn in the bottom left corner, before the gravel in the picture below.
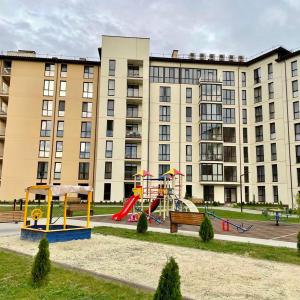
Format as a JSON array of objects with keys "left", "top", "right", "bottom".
[{"left": 0, "top": 251, "right": 152, "bottom": 300}]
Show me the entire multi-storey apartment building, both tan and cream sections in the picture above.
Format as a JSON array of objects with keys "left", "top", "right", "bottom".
[{"left": 0, "top": 36, "right": 300, "bottom": 207}]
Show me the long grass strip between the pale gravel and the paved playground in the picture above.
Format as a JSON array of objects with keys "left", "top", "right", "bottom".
[{"left": 93, "top": 227, "right": 300, "bottom": 265}]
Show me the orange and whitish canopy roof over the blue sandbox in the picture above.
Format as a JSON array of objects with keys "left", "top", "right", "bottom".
[{"left": 26, "top": 185, "right": 93, "bottom": 196}]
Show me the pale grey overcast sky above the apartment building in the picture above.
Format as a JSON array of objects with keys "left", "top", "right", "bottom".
[{"left": 0, "top": 0, "right": 300, "bottom": 57}]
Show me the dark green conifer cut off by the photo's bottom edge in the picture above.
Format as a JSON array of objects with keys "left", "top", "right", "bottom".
[{"left": 153, "top": 257, "right": 182, "bottom": 300}]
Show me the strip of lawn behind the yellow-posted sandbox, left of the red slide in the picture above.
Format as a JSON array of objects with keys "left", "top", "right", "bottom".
[{"left": 0, "top": 205, "right": 121, "bottom": 217}]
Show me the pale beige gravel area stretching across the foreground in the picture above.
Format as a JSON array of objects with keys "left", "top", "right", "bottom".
[{"left": 0, "top": 234, "right": 300, "bottom": 300}]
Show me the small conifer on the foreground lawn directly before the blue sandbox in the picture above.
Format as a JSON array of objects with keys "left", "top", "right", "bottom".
[{"left": 31, "top": 238, "right": 51, "bottom": 286}]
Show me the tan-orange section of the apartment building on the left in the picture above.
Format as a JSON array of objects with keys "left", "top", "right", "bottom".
[{"left": 0, "top": 51, "right": 100, "bottom": 200}]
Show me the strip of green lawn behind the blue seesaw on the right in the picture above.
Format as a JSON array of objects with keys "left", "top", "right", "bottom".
[{"left": 199, "top": 208, "right": 300, "bottom": 223}]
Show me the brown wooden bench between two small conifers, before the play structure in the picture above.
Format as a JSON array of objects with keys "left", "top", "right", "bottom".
[{"left": 169, "top": 211, "right": 205, "bottom": 233}]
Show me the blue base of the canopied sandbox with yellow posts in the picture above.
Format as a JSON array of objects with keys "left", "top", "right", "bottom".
[{"left": 21, "top": 225, "right": 91, "bottom": 243}]
